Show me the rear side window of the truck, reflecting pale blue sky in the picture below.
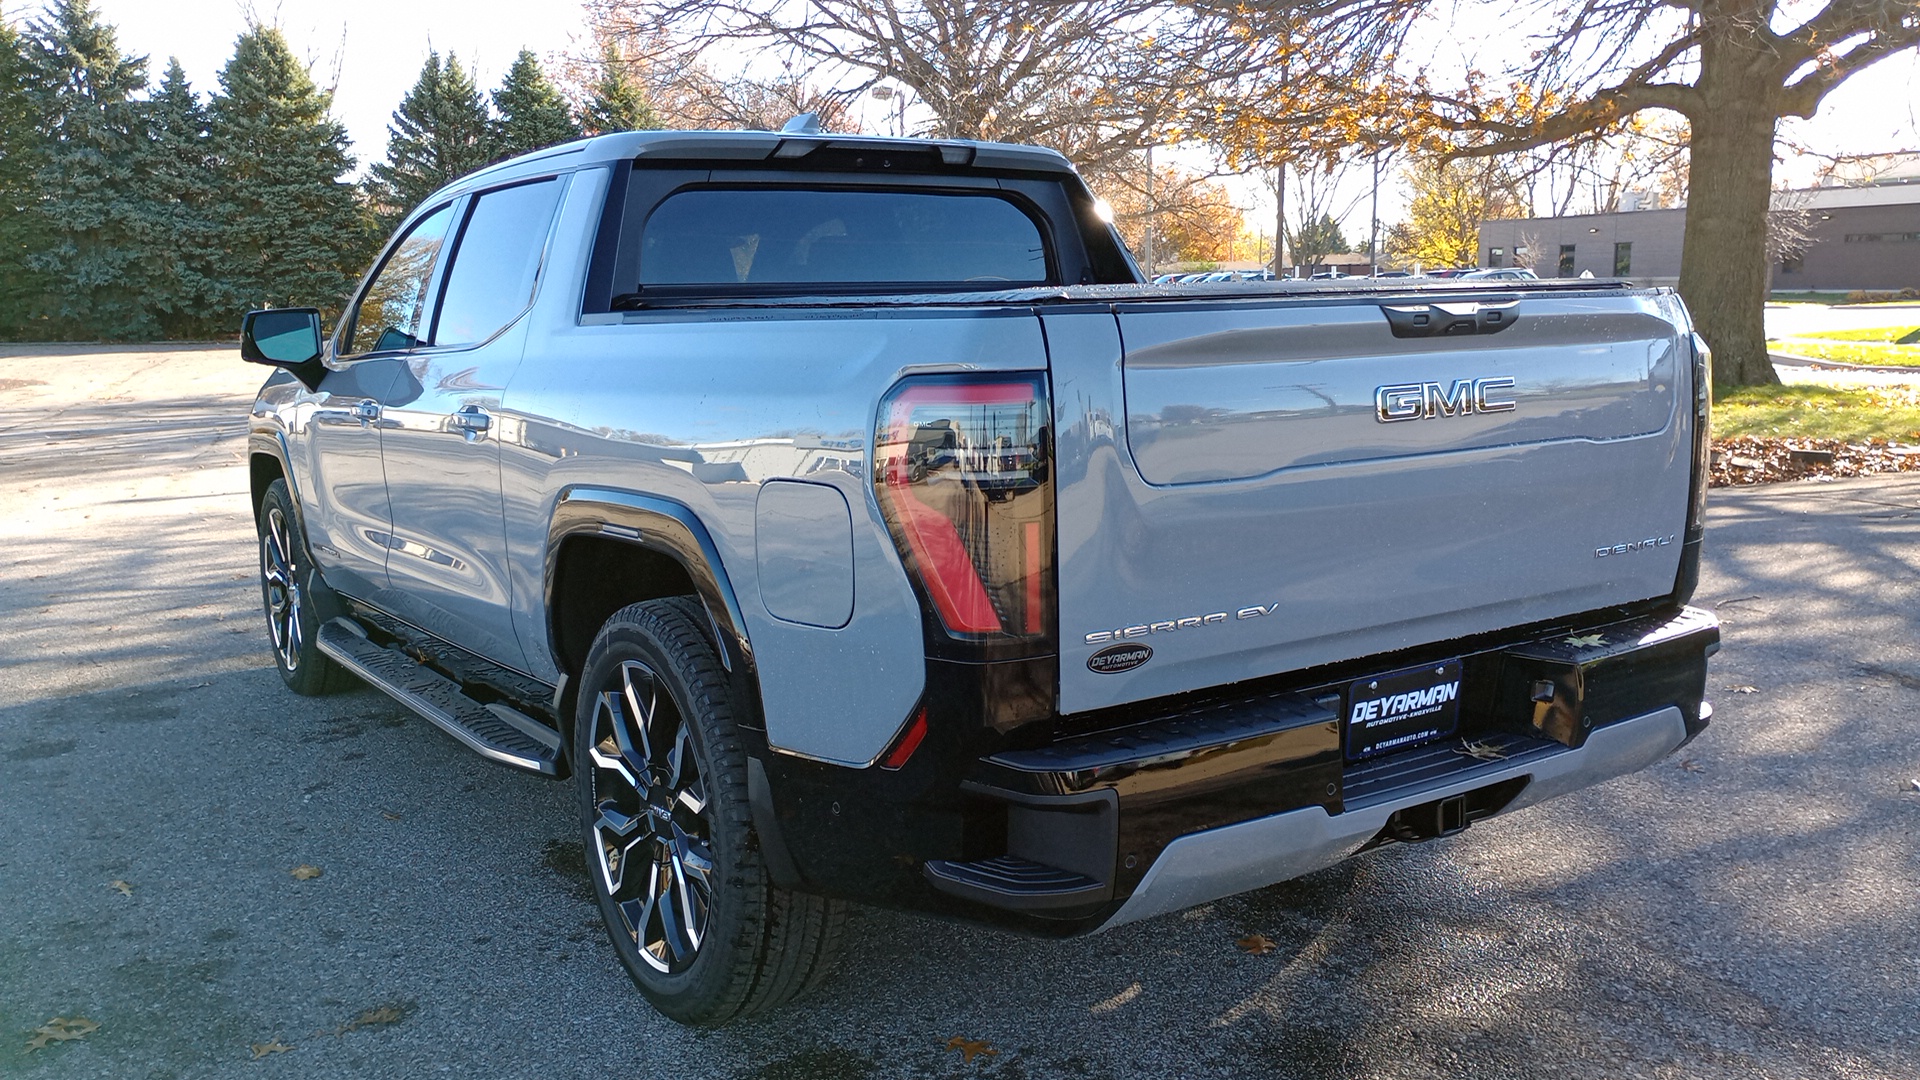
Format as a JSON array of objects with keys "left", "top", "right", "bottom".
[{"left": 434, "top": 179, "right": 563, "bottom": 346}]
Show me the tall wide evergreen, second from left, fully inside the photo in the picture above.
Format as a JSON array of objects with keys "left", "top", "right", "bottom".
[{"left": 25, "top": 0, "right": 159, "bottom": 338}]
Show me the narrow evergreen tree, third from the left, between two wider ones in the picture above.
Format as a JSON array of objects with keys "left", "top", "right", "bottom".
[{"left": 134, "top": 60, "right": 219, "bottom": 338}]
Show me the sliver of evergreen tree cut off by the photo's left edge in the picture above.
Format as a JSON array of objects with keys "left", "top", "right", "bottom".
[{"left": 0, "top": 17, "right": 44, "bottom": 338}]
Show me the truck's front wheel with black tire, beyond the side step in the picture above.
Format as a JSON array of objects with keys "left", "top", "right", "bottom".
[{"left": 257, "top": 480, "right": 357, "bottom": 696}]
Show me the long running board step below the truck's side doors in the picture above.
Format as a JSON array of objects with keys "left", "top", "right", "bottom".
[{"left": 319, "top": 619, "right": 561, "bottom": 776}]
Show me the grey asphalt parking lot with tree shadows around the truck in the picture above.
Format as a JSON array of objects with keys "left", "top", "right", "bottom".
[{"left": 0, "top": 348, "right": 1920, "bottom": 1080}]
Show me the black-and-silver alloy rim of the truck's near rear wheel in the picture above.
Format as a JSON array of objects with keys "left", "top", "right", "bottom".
[{"left": 588, "top": 659, "right": 714, "bottom": 974}]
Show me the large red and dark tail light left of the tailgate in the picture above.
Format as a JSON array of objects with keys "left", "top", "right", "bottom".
[{"left": 874, "top": 375, "right": 1054, "bottom": 644}]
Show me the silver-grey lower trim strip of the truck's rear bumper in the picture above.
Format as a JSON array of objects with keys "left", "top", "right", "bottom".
[{"left": 1102, "top": 707, "right": 1688, "bottom": 928}]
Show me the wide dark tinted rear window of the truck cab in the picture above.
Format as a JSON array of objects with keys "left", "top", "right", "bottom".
[{"left": 639, "top": 188, "right": 1046, "bottom": 284}]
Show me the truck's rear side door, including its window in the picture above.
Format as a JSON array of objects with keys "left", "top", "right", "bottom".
[{"left": 366, "top": 177, "right": 566, "bottom": 667}]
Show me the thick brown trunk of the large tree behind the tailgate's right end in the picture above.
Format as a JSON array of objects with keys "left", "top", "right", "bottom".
[{"left": 1680, "top": 35, "right": 1780, "bottom": 386}]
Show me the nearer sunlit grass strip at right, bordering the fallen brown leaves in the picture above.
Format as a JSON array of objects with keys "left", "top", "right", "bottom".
[{"left": 1713, "top": 382, "right": 1920, "bottom": 442}]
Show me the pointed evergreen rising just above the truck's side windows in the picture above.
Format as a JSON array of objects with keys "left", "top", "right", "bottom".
[{"left": 369, "top": 52, "right": 493, "bottom": 227}]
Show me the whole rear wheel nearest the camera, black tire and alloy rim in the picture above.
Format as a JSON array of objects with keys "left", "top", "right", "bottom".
[{"left": 572, "top": 598, "right": 845, "bottom": 1024}]
